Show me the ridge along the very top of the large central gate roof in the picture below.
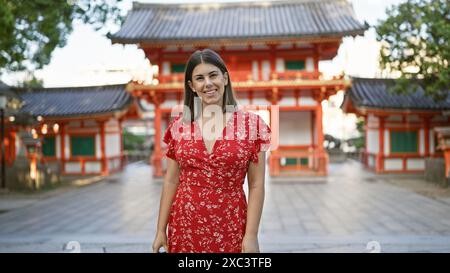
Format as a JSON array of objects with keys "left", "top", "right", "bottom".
[{"left": 132, "top": 0, "right": 348, "bottom": 9}]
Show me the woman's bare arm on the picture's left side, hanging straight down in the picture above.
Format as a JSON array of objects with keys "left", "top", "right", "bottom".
[{"left": 153, "top": 158, "right": 180, "bottom": 253}]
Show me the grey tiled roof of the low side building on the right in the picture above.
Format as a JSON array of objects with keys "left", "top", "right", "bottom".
[{"left": 344, "top": 78, "right": 450, "bottom": 110}]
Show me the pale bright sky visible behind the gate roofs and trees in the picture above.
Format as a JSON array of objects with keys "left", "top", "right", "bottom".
[{"left": 1, "top": 0, "right": 404, "bottom": 138}]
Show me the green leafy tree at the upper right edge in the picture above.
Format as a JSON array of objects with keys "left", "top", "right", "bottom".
[{"left": 376, "top": 0, "right": 450, "bottom": 101}]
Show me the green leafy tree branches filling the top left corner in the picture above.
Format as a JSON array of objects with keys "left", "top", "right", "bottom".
[{"left": 0, "top": 0, "right": 122, "bottom": 72}]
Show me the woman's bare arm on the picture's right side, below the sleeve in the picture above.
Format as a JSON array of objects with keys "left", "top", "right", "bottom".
[{"left": 242, "top": 152, "right": 266, "bottom": 253}]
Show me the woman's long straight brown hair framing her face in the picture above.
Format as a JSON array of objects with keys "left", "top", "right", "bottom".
[{"left": 183, "top": 48, "right": 237, "bottom": 122}]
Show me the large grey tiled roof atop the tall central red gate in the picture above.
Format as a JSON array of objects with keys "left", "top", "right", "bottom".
[{"left": 110, "top": 0, "right": 366, "bottom": 43}]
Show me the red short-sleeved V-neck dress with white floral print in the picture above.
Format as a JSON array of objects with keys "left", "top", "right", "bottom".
[{"left": 163, "top": 110, "right": 271, "bottom": 253}]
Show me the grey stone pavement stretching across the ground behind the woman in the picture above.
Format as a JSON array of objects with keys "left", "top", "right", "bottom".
[{"left": 0, "top": 160, "right": 450, "bottom": 252}]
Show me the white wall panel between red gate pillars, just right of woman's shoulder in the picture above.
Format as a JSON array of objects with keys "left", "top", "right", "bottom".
[{"left": 280, "top": 111, "right": 312, "bottom": 145}]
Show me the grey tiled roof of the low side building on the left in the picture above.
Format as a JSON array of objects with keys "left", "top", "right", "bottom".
[{"left": 18, "top": 84, "right": 132, "bottom": 117}]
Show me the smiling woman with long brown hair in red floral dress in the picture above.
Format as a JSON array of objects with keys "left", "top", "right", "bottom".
[{"left": 153, "top": 49, "right": 270, "bottom": 252}]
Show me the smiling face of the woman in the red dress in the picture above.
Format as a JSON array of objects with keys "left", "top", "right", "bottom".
[{"left": 188, "top": 63, "right": 228, "bottom": 106}]
